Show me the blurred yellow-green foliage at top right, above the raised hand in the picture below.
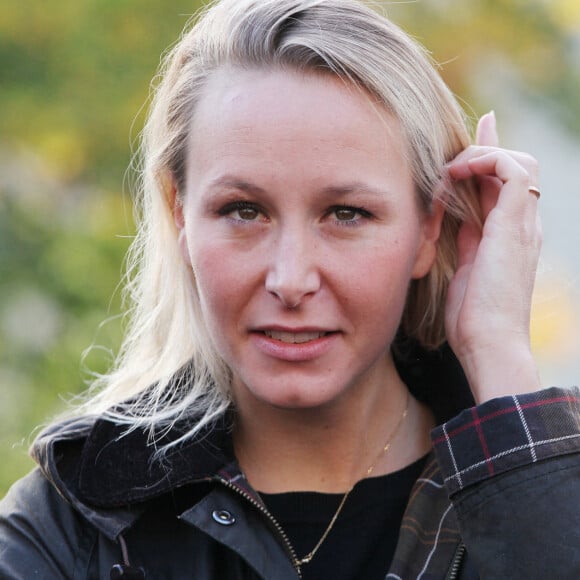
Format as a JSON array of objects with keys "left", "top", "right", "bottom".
[{"left": 383, "top": 0, "right": 580, "bottom": 133}]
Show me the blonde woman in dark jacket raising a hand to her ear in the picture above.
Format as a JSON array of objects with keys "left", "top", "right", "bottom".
[{"left": 0, "top": 0, "right": 580, "bottom": 579}]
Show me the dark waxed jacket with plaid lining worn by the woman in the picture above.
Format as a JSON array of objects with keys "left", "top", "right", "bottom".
[{"left": 0, "top": 344, "right": 580, "bottom": 580}]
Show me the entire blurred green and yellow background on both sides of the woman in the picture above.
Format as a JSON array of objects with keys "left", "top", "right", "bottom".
[{"left": 0, "top": 0, "right": 580, "bottom": 497}]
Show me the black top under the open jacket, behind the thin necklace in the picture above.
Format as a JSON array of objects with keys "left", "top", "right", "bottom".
[{"left": 260, "top": 458, "right": 425, "bottom": 580}]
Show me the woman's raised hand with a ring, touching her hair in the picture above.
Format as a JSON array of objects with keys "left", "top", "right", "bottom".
[{"left": 446, "top": 113, "right": 542, "bottom": 403}]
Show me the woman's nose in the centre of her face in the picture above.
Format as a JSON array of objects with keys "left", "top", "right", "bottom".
[{"left": 266, "top": 228, "right": 320, "bottom": 308}]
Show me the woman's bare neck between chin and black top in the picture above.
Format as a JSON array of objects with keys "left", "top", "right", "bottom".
[{"left": 234, "top": 362, "right": 433, "bottom": 493}]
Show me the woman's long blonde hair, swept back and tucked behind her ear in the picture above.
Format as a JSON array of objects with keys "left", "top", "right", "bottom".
[{"left": 84, "top": 0, "right": 477, "bottom": 443}]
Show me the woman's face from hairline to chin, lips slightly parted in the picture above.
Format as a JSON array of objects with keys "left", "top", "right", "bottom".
[{"left": 176, "top": 69, "right": 440, "bottom": 408}]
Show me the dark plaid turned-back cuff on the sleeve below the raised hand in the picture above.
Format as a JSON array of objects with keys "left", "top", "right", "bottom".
[{"left": 431, "top": 387, "right": 580, "bottom": 496}]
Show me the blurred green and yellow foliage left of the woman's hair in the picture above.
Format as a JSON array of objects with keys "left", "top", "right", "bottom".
[{"left": 0, "top": 0, "right": 205, "bottom": 497}]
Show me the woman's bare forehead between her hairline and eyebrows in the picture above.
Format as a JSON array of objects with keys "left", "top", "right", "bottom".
[{"left": 187, "top": 68, "right": 410, "bottom": 193}]
